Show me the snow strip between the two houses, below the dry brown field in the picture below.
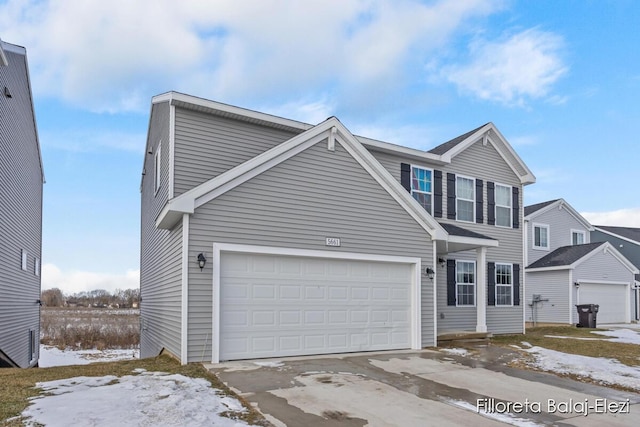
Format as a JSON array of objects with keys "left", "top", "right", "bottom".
[{"left": 38, "top": 345, "right": 140, "bottom": 368}]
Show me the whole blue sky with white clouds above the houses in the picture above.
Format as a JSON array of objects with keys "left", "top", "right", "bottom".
[{"left": 0, "top": 0, "right": 640, "bottom": 293}]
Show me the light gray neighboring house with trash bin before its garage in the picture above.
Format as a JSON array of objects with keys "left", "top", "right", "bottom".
[{"left": 524, "top": 199, "right": 638, "bottom": 324}]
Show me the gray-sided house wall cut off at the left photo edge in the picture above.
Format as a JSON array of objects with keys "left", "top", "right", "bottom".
[{"left": 0, "top": 41, "right": 44, "bottom": 368}]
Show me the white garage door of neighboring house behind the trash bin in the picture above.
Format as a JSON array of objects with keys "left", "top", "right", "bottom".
[{"left": 579, "top": 283, "right": 631, "bottom": 324}]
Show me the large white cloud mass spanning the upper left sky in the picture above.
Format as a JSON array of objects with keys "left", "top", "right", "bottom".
[{"left": 0, "top": 0, "right": 502, "bottom": 112}]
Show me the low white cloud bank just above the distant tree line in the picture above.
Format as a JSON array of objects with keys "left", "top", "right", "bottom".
[{"left": 42, "top": 263, "right": 140, "bottom": 295}]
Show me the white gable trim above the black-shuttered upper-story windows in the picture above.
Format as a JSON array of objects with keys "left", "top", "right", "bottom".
[{"left": 441, "top": 123, "right": 536, "bottom": 185}]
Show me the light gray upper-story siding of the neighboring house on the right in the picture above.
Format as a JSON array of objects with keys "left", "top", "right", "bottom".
[{"left": 527, "top": 208, "right": 591, "bottom": 265}]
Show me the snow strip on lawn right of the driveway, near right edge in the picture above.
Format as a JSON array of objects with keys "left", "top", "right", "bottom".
[{"left": 522, "top": 342, "right": 640, "bottom": 391}]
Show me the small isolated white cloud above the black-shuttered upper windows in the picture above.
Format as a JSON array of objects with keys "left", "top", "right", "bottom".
[{"left": 442, "top": 29, "right": 568, "bottom": 105}]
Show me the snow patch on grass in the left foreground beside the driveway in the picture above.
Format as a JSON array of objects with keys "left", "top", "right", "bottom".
[{"left": 22, "top": 369, "right": 258, "bottom": 427}]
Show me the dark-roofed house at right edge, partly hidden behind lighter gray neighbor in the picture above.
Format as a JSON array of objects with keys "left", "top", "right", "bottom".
[{"left": 591, "top": 225, "right": 640, "bottom": 320}]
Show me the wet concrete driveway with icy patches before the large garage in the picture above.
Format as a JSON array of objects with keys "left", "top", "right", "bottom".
[{"left": 206, "top": 346, "right": 640, "bottom": 427}]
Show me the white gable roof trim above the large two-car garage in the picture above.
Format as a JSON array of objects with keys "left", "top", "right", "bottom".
[{"left": 156, "top": 117, "right": 447, "bottom": 240}]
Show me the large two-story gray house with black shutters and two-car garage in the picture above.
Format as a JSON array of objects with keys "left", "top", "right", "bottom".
[{"left": 140, "top": 92, "right": 535, "bottom": 363}]
